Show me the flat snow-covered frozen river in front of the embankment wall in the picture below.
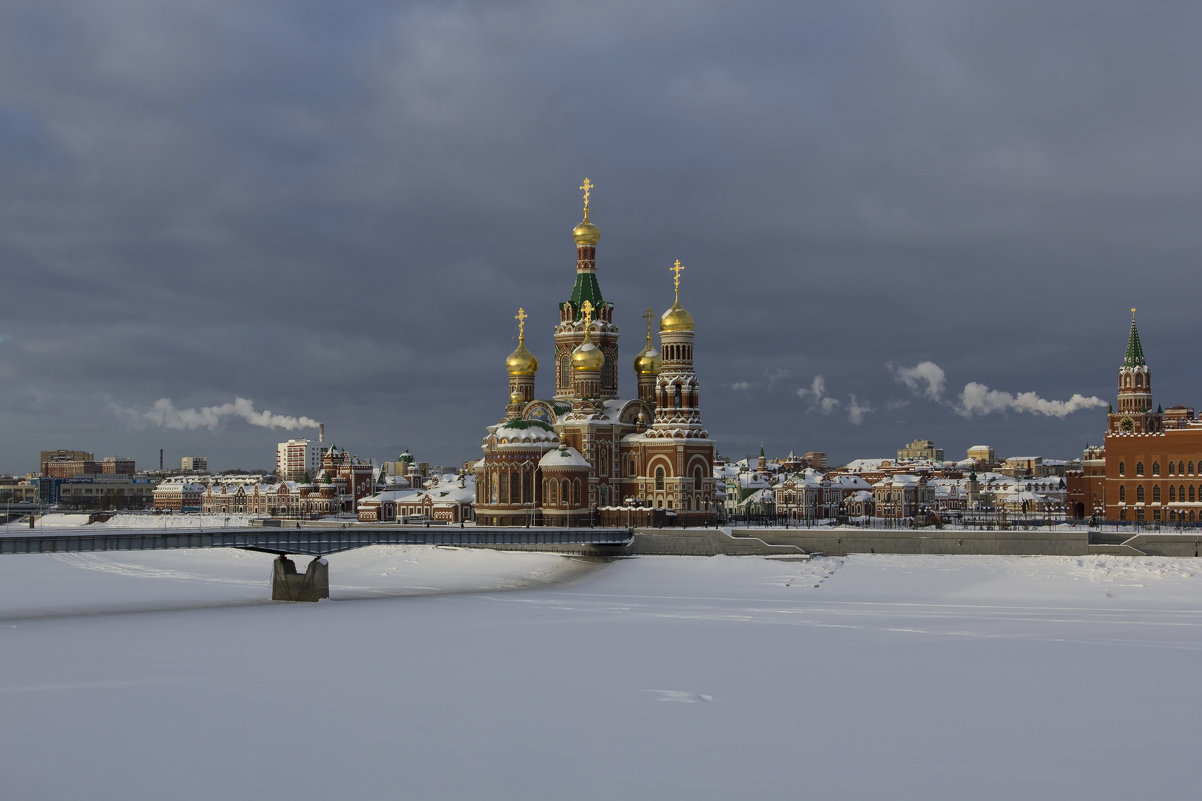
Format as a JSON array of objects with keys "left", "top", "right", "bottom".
[{"left": 0, "top": 538, "right": 1202, "bottom": 801}]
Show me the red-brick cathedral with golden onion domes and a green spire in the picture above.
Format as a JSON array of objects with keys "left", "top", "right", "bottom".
[{"left": 475, "top": 178, "right": 718, "bottom": 526}]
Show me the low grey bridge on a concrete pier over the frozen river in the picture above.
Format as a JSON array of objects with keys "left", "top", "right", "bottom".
[{"left": 0, "top": 524, "right": 633, "bottom": 601}]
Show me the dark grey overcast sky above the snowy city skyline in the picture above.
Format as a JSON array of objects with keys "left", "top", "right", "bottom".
[{"left": 0, "top": 0, "right": 1202, "bottom": 471}]
